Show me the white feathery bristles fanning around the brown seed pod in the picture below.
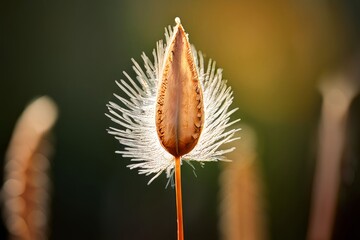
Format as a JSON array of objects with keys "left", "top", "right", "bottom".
[{"left": 106, "top": 20, "right": 239, "bottom": 183}]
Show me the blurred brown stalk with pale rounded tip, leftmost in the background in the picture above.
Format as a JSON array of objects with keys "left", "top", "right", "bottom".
[{"left": 2, "top": 97, "right": 58, "bottom": 240}]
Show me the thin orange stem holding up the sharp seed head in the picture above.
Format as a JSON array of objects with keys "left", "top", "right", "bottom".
[{"left": 175, "top": 157, "right": 184, "bottom": 240}]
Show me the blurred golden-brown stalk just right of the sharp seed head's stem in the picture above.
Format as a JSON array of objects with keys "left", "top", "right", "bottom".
[{"left": 219, "top": 126, "right": 267, "bottom": 240}]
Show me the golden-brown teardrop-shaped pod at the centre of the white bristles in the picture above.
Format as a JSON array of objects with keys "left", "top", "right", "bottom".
[{"left": 156, "top": 24, "right": 204, "bottom": 157}]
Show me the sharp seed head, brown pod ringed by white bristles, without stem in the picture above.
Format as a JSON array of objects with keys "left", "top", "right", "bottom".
[{"left": 106, "top": 18, "right": 239, "bottom": 183}]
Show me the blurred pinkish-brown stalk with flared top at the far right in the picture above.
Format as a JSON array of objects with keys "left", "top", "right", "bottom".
[{"left": 307, "top": 51, "right": 360, "bottom": 240}]
